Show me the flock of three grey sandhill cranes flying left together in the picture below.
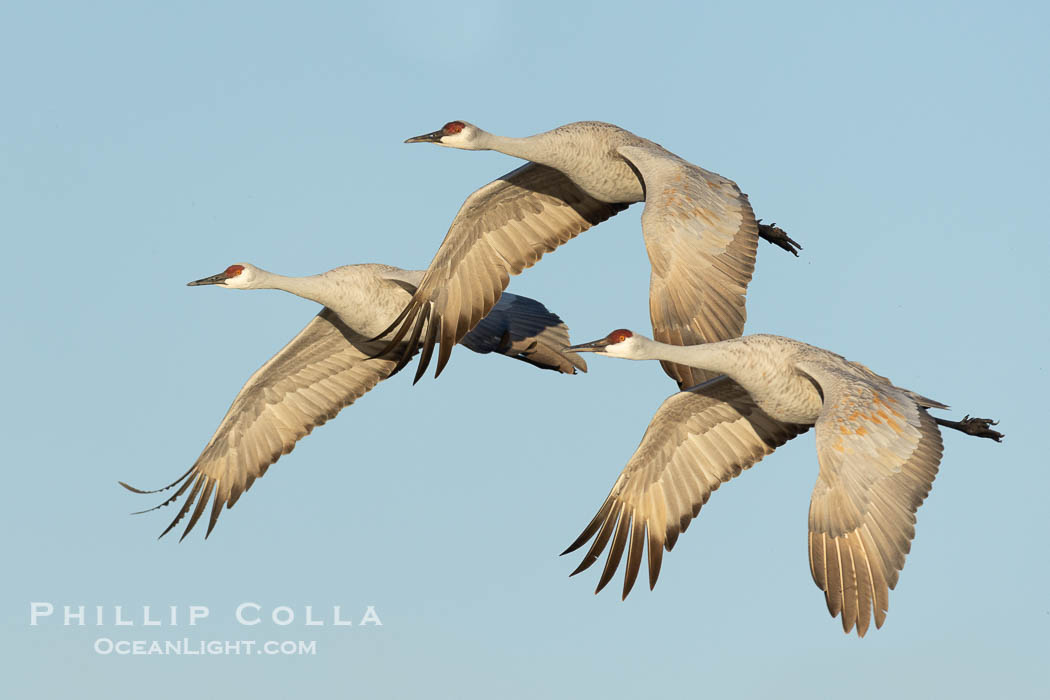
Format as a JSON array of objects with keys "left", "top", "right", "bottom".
[{"left": 122, "top": 121, "right": 1003, "bottom": 636}]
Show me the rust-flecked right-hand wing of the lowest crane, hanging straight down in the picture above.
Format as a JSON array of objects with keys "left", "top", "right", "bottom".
[{"left": 800, "top": 364, "right": 942, "bottom": 637}]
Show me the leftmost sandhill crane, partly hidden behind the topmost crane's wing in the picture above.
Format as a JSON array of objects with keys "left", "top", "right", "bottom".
[{"left": 121, "top": 262, "right": 587, "bottom": 539}]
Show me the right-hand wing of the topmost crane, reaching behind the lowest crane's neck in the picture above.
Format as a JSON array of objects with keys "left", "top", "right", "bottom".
[{"left": 618, "top": 144, "right": 758, "bottom": 388}]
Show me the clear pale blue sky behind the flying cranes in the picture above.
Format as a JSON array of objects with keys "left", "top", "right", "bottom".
[{"left": 0, "top": 2, "right": 1050, "bottom": 698}]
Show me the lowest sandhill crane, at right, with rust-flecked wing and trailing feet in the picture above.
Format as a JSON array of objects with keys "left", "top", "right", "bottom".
[{"left": 563, "top": 330, "right": 1003, "bottom": 637}]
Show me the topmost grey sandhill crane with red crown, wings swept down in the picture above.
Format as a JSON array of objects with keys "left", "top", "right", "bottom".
[{"left": 377, "top": 121, "right": 800, "bottom": 387}]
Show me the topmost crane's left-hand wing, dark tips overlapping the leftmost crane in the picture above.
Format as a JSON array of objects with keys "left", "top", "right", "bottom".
[{"left": 382, "top": 163, "right": 627, "bottom": 380}]
